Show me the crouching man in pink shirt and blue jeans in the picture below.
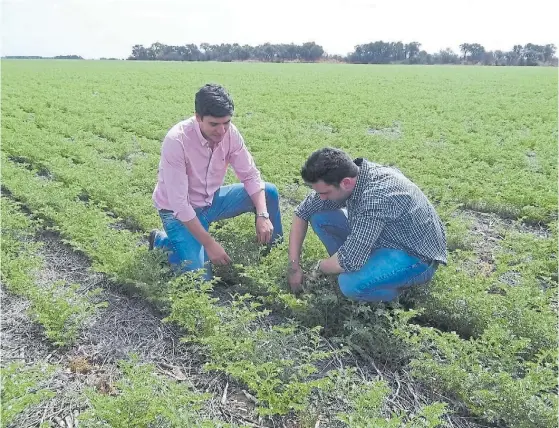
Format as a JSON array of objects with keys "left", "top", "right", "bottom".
[{"left": 149, "top": 84, "right": 283, "bottom": 279}]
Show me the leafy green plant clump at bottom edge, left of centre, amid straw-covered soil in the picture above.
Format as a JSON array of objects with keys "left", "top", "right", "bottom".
[{"left": 79, "top": 359, "right": 230, "bottom": 428}]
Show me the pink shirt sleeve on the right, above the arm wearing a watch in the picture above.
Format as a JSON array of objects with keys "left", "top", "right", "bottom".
[{"left": 229, "top": 125, "right": 265, "bottom": 196}]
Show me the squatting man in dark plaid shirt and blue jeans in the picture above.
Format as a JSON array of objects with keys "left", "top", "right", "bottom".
[{"left": 289, "top": 148, "right": 447, "bottom": 302}]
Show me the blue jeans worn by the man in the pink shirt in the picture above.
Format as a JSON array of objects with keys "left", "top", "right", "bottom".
[{"left": 153, "top": 183, "right": 283, "bottom": 280}]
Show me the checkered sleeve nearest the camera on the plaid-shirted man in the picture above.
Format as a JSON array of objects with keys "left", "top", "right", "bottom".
[{"left": 337, "top": 194, "right": 386, "bottom": 272}]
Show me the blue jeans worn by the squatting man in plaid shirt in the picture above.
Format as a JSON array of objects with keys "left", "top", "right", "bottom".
[{"left": 310, "top": 210, "right": 437, "bottom": 302}]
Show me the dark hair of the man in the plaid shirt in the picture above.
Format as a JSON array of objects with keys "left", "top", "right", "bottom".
[{"left": 301, "top": 147, "right": 359, "bottom": 186}]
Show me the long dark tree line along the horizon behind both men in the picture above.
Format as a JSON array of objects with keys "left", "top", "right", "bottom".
[{"left": 128, "top": 40, "right": 557, "bottom": 66}]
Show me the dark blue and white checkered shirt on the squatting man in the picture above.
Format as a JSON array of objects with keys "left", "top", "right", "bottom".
[{"left": 295, "top": 158, "right": 447, "bottom": 272}]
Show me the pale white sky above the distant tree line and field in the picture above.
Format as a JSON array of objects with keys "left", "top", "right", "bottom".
[{"left": 0, "top": 0, "right": 559, "bottom": 59}]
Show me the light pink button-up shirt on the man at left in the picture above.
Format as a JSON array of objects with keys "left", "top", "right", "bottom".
[{"left": 152, "top": 117, "right": 264, "bottom": 222}]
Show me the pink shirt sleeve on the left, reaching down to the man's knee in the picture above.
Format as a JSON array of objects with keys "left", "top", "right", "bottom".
[{"left": 161, "top": 137, "right": 196, "bottom": 222}]
